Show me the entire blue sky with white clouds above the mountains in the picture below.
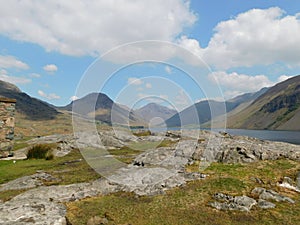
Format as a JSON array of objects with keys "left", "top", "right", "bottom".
[{"left": 0, "top": 0, "right": 300, "bottom": 110}]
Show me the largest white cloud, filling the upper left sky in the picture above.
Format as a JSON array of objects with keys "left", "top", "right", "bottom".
[{"left": 0, "top": 0, "right": 196, "bottom": 56}]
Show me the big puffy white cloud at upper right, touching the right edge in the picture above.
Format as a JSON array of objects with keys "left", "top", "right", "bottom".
[{"left": 203, "top": 7, "right": 300, "bottom": 69}]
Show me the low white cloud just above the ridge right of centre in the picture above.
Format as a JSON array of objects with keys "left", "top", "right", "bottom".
[{"left": 208, "top": 71, "right": 274, "bottom": 99}]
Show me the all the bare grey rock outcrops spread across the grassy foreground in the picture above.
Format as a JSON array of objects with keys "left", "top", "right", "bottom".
[{"left": 0, "top": 131, "right": 300, "bottom": 225}]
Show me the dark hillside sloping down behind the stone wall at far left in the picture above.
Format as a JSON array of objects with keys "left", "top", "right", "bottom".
[{"left": 0, "top": 80, "right": 59, "bottom": 120}]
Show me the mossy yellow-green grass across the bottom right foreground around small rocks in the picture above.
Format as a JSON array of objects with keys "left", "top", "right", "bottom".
[{"left": 66, "top": 160, "right": 300, "bottom": 225}]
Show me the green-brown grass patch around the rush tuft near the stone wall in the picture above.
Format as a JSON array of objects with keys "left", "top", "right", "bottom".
[{"left": 0, "top": 150, "right": 100, "bottom": 200}]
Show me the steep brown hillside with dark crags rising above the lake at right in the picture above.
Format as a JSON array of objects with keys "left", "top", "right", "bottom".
[{"left": 227, "top": 76, "right": 300, "bottom": 130}]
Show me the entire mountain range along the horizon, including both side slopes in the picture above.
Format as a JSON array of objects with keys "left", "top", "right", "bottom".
[{"left": 0, "top": 76, "right": 300, "bottom": 130}]
